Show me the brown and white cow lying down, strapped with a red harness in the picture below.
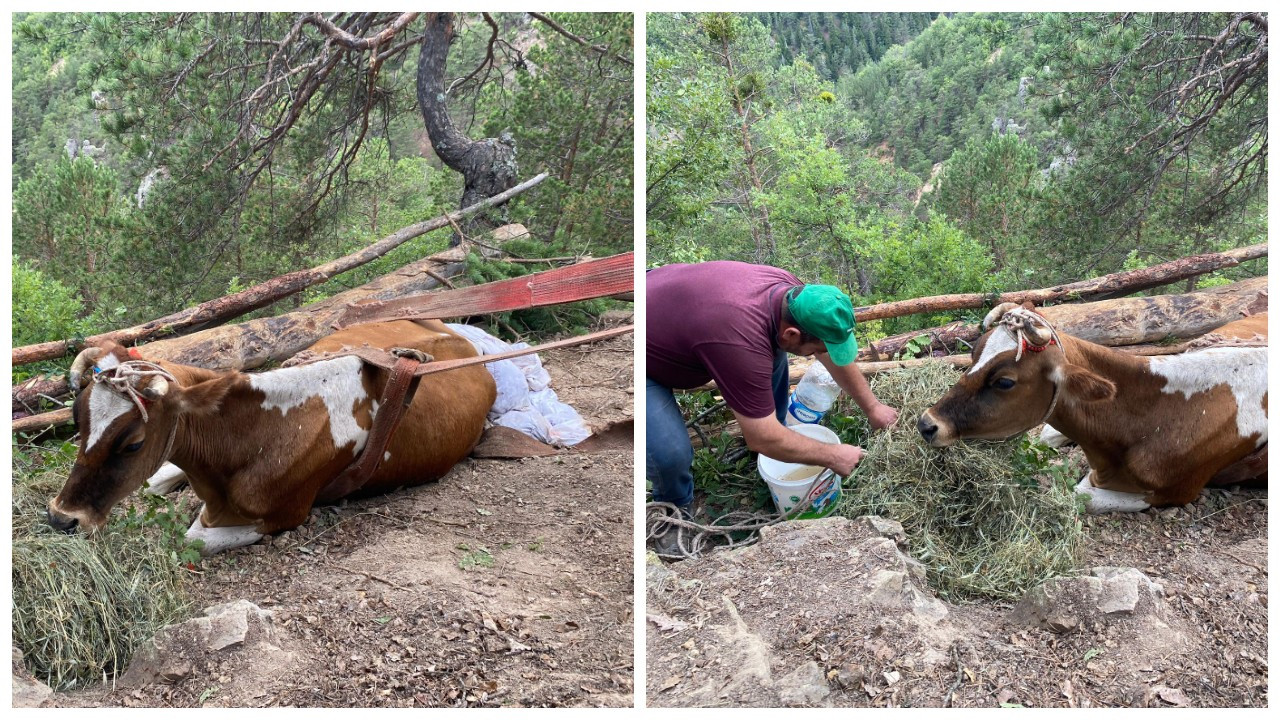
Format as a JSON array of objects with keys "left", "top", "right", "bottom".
[{"left": 49, "top": 320, "right": 495, "bottom": 555}]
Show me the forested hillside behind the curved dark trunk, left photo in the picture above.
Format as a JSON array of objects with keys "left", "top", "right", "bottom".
[{"left": 13, "top": 13, "right": 634, "bottom": 363}]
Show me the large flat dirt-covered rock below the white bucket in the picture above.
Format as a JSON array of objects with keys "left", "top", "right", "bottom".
[{"left": 646, "top": 516, "right": 957, "bottom": 707}]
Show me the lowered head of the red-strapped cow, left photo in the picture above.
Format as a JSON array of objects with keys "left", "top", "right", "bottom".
[{"left": 49, "top": 342, "right": 217, "bottom": 532}]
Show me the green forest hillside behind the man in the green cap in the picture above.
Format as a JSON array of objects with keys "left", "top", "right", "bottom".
[{"left": 646, "top": 13, "right": 1267, "bottom": 340}]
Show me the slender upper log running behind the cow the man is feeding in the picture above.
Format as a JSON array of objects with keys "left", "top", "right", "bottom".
[{"left": 854, "top": 243, "right": 1267, "bottom": 323}]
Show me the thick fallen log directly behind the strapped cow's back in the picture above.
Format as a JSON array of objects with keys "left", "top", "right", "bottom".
[{"left": 12, "top": 224, "right": 529, "bottom": 413}]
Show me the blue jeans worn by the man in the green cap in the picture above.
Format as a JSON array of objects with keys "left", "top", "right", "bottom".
[{"left": 645, "top": 350, "right": 791, "bottom": 507}]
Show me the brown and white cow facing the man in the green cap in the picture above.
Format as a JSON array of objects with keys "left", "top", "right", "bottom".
[{"left": 918, "top": 302, "right": 1267, "bottom": 512}]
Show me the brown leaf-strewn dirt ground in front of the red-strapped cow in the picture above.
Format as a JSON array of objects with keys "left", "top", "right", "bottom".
[{"left": 45, "top": 322, "right": 634, "bottom": 707}]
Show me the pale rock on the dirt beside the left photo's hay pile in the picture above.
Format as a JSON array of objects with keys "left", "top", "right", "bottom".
[{"left": 119, "top": 600, "right": 283, "bottom": 687}]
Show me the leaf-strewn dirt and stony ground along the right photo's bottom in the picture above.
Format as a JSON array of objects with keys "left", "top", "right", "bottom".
[{"left": 645, "top": 466, "right": 1268, "bottom": 707}]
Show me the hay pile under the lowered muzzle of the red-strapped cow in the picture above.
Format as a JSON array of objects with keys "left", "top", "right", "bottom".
[{"left": 13, "top": 448, "right": 189, "bottom": 689}]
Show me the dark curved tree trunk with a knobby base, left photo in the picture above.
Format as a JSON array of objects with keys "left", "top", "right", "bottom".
[{"left": 417, "top": 13, "right": 517, "bottom": 245}]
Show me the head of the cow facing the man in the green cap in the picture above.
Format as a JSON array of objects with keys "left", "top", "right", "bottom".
[{"left": 916, "top": 302, "right": 1115, "bottom": 447}]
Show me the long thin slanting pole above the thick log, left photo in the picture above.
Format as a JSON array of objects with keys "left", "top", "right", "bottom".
[{"left": 13, "top": 173, "right": 547, "bottom": 366}]
